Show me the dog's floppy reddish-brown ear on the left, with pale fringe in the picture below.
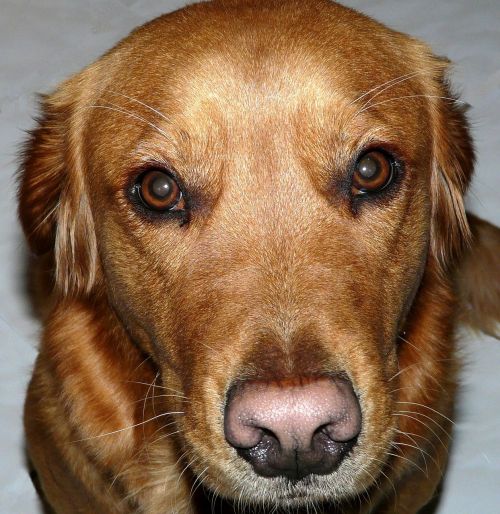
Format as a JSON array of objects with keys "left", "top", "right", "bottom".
[{"left": 19, "top": 81, "right": 98, "bottom": 295}]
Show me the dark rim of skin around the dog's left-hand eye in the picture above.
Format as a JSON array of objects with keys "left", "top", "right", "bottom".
[{"left": 126, "top": 162, "right": 191, "bottom": 221}]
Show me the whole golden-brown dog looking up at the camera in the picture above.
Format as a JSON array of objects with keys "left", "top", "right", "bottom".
[{"left": 19, "top": 0, "right": 500, "bottom": 514}]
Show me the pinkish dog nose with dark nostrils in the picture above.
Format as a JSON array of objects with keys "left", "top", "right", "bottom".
[{"left": 224, "top": 377, "right": 361, "bottom": 479}]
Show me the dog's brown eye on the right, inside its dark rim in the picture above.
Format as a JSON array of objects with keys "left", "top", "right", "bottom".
[{"left": 352, "top": 150, "right": 394, "bottom": 195}]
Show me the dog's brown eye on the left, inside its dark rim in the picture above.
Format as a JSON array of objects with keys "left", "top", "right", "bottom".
[{"left": 137, "top": 170, "right": 185, "bottom": 211}]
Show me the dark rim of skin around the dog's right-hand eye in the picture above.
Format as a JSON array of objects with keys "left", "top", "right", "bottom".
[{"left": 349, "top": 145, "right": 404, "bottom": 202}]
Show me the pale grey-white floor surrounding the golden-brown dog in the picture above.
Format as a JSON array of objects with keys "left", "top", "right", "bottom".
[{"left": 0, "top": 0, "right": 500, "bottom": 514}]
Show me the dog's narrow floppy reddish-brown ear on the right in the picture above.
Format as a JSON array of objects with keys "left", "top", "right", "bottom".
[{"left": 431, "top": 59, "right": 474, "bottom": 269}]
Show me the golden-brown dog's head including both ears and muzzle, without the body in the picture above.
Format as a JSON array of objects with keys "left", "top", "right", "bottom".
[{"left": 20, "top": 1, "right": 472, "bottom": 505}]
